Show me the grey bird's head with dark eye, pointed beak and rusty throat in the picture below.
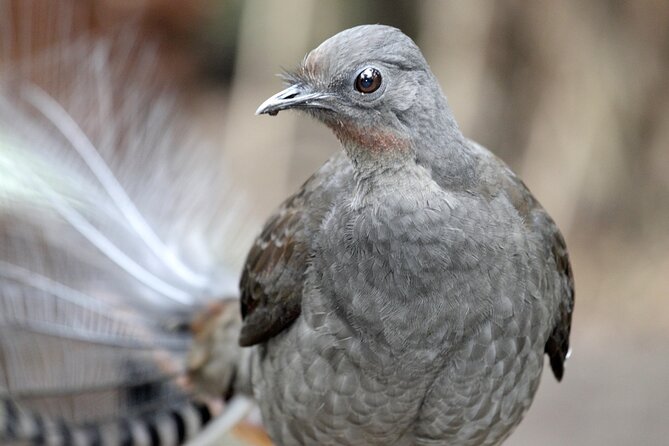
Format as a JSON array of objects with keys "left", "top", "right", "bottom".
[{"left": 256, "top": 25, "right": 433, "bottom": 156}]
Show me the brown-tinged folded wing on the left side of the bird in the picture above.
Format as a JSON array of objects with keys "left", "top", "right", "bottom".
[{"left": 239, "top": 153, "right": 352, "bottom": 346}]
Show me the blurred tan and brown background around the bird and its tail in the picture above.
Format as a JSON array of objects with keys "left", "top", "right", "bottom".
[{"left": 0, "top": 0, "right": 669, "bottom": 446}]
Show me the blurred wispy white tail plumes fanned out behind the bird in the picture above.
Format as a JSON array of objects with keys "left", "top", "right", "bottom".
[{"left": 0, "top": 2, "right": 253, "bottom": 445}]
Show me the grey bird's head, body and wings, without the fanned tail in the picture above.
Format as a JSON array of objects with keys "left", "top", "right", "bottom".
[{"left": 240, "top": 25, "right": 573, "bottom": 445}]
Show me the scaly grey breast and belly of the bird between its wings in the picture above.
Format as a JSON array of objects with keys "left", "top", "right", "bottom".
[{"left": 252, "top": 148, "right": 556, "bottom": 445}]
